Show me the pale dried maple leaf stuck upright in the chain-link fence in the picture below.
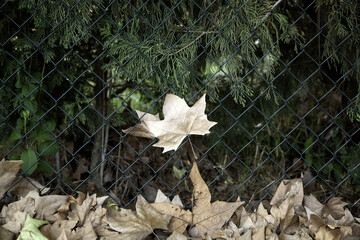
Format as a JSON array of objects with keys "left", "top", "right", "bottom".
[{"left": 124, "top": 94, "right": 216, "bottom": 152}]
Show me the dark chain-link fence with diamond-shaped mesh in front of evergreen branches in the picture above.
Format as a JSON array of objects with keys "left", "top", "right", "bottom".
[{"left": 0, "top": 0, "right": 360, "bottom": 214}]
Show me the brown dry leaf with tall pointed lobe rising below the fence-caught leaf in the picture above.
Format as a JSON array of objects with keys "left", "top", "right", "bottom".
[{"left": 151, "top": 163, "right": 244, "bottom": 238}]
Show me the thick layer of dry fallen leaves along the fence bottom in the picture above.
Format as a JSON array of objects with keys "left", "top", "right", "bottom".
[{"left": 0, "top": 160, "right": 360, "bottom": 240}]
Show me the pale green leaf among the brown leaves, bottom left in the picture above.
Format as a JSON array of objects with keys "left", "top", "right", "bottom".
[{"left": 17, "top": 214, "right": 49, "bottom": 240}]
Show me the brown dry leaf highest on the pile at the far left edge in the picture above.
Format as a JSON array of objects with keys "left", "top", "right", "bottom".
[{"left": 0, "top": 160, "right": 23, "bottom": 198}]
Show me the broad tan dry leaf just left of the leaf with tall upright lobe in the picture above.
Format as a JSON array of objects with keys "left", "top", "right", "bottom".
[{"left": 106, "top": 195, "right": 171, "bottom": 240}]
